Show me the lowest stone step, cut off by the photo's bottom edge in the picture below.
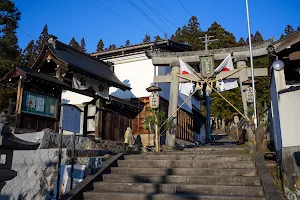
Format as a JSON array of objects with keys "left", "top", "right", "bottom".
[{"left": 83, "top": 192, "right": 266, "bottom": 200}]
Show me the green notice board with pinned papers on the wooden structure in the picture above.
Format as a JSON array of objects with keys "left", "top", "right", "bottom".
[{"left": 22, "top": 90, "right": 57, "bottom": 118}]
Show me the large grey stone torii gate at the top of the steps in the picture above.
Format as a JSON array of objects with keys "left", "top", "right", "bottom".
[{"left": 146, "top": 39, "right": 273, "bottom": 147}]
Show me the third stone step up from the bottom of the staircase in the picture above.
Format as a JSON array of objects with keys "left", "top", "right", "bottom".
[{"left": 103, "top": 174, "right": 260, "bottom": 186}]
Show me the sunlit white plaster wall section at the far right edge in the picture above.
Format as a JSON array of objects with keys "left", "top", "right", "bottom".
[{"left": 278, "top": 90, "right": 300, "bottom": 147}]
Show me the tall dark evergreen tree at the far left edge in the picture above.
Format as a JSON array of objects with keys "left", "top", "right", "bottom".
[{"left": 0, "top": 0, "right": 21, "bottom": 113}]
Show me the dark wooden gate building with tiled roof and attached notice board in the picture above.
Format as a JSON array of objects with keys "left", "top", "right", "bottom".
[{"left": 1, "top": 37, "right": 140, "bottom": 137}]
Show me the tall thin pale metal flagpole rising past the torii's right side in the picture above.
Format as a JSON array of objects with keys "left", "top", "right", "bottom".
[{"left": 246, "top": 0, "right": 257, "bottom": 129}]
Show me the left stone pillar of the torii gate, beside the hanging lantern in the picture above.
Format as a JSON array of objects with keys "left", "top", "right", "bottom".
[{"left": 166, "top": 60, "right": 180, "bottom": 148}]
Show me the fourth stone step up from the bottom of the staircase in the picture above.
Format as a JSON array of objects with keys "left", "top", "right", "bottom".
[{"left": 111, "top": 167, "right": 257, "bottom": 176}]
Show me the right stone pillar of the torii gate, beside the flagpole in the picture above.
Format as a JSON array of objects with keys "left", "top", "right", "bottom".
[{"left": 234, "top": 56, "right": 248, "bottom": 117}]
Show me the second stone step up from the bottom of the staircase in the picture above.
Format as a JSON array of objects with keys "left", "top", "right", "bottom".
[{"left": 94, "top": 182, "right": 264, "bottom": 197}]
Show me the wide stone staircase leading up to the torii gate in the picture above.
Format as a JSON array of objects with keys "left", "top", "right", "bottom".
[{"left": 84, "top": 147, "right": 266, "bottom": 200}]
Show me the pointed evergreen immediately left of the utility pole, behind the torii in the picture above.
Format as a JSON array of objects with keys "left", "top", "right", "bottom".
[{"left": 171, "top": 16, "right": 204, "bottom": 50}]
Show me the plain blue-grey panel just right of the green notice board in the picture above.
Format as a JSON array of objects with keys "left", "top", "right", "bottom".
[{"left": 62, "top": 104, "right": 81, "bottom": 133}]
